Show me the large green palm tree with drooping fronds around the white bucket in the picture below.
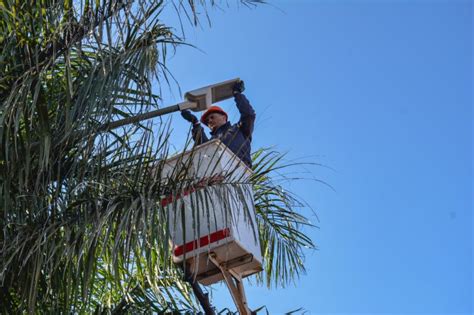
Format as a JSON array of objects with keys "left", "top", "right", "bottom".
[{"left": 0, "top": 0, "right": 314, "bottom": 313}]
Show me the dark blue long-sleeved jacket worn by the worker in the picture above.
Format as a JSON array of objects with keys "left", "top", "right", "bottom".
[{"left": 193, "top": 94, "right": 255, "bottom": 167}]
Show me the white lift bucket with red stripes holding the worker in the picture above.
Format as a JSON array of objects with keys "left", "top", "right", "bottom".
[{"left": 161, "top": 140, "right": 262, "bottom": 285}]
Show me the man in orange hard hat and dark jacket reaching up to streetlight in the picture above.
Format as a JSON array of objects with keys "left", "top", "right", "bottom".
[{"left": 181, "top": 81, "right": 255, "bottom": 167}]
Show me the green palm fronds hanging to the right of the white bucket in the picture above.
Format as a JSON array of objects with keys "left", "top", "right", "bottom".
[{"left": 251, "top": 148, "right": 316, "bottom": 287}]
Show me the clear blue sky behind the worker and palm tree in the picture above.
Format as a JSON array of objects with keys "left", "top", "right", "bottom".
[{"left": 158, "top": 0, "right": 474, "bottom": 314}]
